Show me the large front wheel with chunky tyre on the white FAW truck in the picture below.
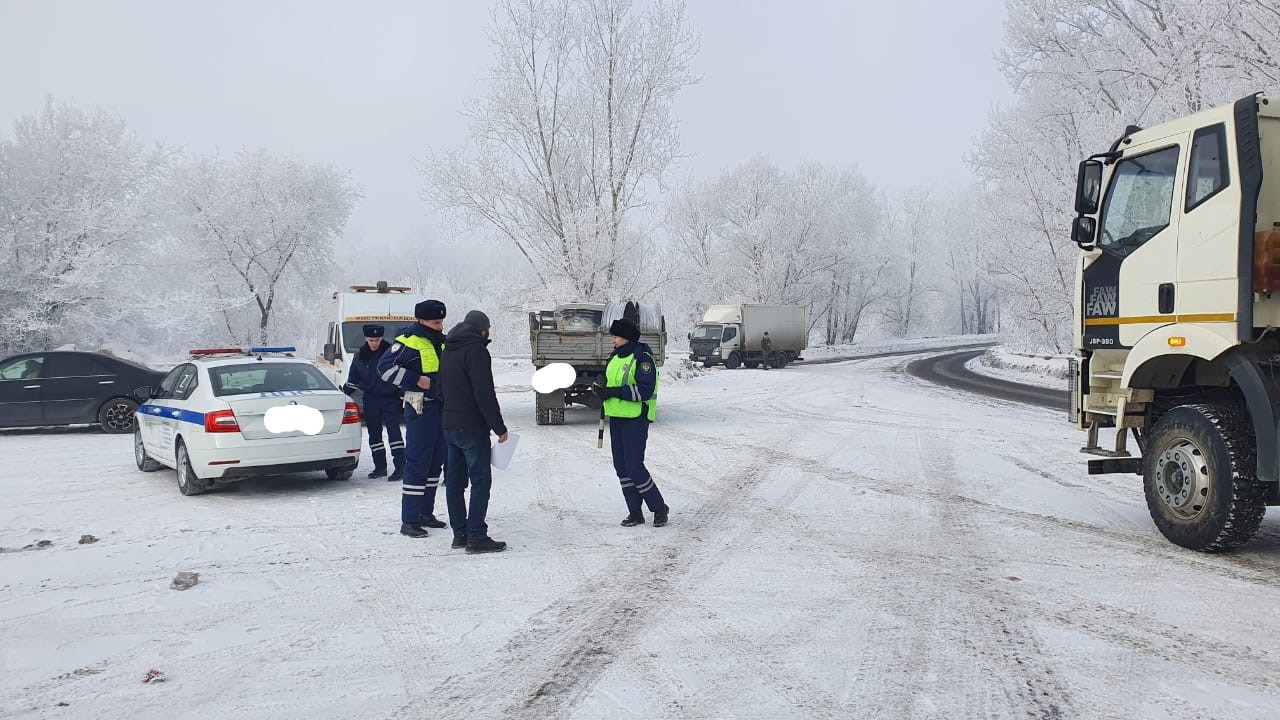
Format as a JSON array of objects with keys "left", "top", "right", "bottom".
[{"left": 1143, "top": 402, "right": 1266, "bottom": 552}]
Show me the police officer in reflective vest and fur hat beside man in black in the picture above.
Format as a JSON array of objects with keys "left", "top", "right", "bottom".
[{"left": 378, "top": 294, "right": 445, "bottom": 538}]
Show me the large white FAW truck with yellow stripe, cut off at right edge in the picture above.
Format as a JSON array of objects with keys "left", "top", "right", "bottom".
[{"left": 1069, "top": 89, "right": 1280, "bottom": 552}]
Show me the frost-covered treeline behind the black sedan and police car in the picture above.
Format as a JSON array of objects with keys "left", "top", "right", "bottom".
[{"left": 0, "top": 99, "right": 357, "bottom": 357}]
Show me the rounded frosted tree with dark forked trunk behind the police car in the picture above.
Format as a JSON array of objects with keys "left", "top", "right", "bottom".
[{"left": 174, "top": 150, "right": 360, "bottom": 343}]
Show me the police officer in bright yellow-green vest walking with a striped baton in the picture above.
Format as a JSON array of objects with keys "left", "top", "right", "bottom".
[{"left": 591, "top": 318, "right": 671, "bottom": 528}]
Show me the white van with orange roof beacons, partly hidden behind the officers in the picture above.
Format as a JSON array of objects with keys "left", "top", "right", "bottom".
[{"left": 316, "top": 281, "right": 422, "bottom": 387}]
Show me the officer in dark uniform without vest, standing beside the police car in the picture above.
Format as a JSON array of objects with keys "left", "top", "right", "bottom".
[{"left": 342, "top": 324, "right": 404, "bottom": 482}]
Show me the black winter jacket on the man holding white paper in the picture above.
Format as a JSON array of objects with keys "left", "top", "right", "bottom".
[{"left": 440, "top": 323, "right": 507, "bottom": 436}]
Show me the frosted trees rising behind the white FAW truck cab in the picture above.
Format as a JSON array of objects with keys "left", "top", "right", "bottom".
[{"left": 972, "top": 0, "right": 1280, "bottom": 351}]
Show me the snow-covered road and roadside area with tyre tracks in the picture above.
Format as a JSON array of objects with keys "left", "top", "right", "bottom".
[{"left": 0, "top": 357, "right": 1280, "bottom": 720}]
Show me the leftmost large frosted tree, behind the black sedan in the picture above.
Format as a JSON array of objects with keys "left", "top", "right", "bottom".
[{"left": 0, "top": 99, "right": 165, "bottom": 352}]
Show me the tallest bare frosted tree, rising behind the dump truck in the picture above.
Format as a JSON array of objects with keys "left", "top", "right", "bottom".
[{"left": 424, "top": 0, "right": 698, "bottom": 300}]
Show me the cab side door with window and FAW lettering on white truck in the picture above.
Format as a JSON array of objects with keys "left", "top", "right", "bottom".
[{"left": 1083, "top": 133, "right": 1185, "bottom": 350}]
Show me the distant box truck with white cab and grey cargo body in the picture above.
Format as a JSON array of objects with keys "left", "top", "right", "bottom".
[{"left": 689, "top": 305, "right": 809, "bottom": 370}]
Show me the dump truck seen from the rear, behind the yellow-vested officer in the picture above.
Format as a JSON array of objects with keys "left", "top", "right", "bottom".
[{"left": 529, "top": 302, "right": 667, "bottom": 425}]
